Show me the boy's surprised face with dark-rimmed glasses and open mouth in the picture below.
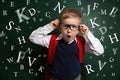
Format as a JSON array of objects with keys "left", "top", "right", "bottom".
[{"left": 60, "top": 18, "right": 80, "bottom": 42}]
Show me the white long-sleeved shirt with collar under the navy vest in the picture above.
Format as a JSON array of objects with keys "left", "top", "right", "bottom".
[{"left": 29, "top": 24, "right": 104, "bottom": 55}]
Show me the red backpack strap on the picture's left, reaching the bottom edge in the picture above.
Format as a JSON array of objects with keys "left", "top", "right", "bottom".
[{"left": 45, "top": 34, "right": 58, "bottom": 80}]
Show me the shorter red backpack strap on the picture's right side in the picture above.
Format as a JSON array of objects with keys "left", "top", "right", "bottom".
[{"left": 76, "top": 36, "right": 85, "bottom": 64}]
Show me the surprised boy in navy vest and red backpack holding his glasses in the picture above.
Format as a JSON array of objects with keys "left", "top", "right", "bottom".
[{"left": 29, "top": 8, "right": 104, "bottom": 80}]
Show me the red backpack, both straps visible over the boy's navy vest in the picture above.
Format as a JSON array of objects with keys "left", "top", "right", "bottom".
[{"left": 45, "top": 34, "right": 85, "bottom": 80}]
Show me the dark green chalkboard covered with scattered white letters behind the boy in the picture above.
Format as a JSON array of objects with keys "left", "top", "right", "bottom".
[{"left": 0, "top": 0, "right": 120, "bottom": 80}]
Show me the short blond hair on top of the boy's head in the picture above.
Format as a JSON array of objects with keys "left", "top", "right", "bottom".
[{"left": 59, "top": 8, "right": 82, "bottom": 23}]
